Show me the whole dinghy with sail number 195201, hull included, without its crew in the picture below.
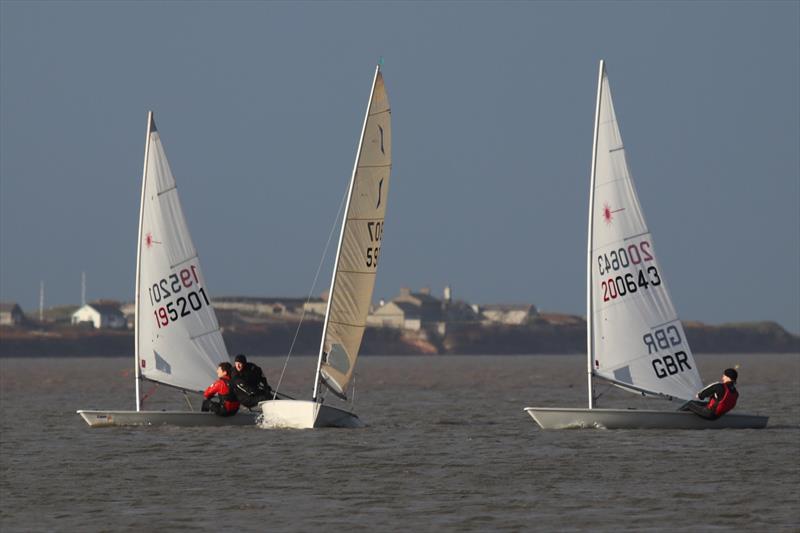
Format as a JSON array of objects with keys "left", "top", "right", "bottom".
[{"left": 78, "top": 112, "right": 255, "bottom": 427}]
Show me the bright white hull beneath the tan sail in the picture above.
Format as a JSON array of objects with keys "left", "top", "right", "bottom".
[{"left": 258, "top": 400, "right": 364, "bottom": 429}]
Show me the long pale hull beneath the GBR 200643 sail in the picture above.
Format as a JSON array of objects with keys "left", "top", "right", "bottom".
[{"left": 525, "top": 407, "right": 769, "bottom": 429}]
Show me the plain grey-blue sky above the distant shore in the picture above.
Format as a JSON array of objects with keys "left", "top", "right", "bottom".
[{"left": 0, "top": 0, "right": 800, "bottom": 333}]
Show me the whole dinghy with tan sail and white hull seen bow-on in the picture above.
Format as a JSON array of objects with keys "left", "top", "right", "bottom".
[{"left": 259, "top": 65, "right": 392, "bottom": 429}]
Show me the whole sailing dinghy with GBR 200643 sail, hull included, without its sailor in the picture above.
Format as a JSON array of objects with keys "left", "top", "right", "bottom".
[{"left": 525, "top": 61, "right": 768, "bottom": 429}]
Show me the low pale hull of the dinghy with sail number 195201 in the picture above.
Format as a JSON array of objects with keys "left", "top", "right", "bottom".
[{"left": 78, "top": 409, "right": 257, "bottom": 428}]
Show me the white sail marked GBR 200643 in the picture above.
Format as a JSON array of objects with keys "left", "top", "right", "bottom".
[{"left": 588, "top": 62, "right": 702, "bottom": 399}]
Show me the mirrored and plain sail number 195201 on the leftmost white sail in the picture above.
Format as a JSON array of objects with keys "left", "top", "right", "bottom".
[{"left": 147, "top": 265, "right": 209, "bottom": 328}]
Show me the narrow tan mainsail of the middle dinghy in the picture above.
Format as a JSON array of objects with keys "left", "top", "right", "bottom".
[{"left": 314, "top": 66, "right": 392, "bottom": 398}]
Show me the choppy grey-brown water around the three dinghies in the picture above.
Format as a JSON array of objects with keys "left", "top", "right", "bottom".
[{"left": 0, "top": 355, "right": 800, "bottom": 532}]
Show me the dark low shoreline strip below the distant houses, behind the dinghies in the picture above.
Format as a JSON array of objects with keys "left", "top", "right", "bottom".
[{"left": 0, "top": 317, "right": 800, "bottom": 357}]
